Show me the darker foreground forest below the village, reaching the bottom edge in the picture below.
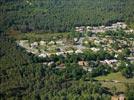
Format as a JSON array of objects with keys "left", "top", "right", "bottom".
[{"left": 0, "top": 33, "right": 134, "bottom": 100}]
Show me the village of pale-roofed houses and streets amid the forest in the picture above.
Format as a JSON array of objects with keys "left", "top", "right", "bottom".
[{"left": 17, "top": 22, "right": 134, "bottom": 72}]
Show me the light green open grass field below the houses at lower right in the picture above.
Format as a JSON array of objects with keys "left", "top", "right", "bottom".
[{"left": 95, "top": 72, "right": 134, "bottom": 92}]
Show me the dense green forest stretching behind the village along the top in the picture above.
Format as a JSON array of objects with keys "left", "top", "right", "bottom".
[{"left": 0, "top": 0, "right": 134, "bottom": 32}]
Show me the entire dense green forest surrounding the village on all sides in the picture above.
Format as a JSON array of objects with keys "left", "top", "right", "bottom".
[{"left": 0, "top": 0, "right": 134, "bottom": 100}]
